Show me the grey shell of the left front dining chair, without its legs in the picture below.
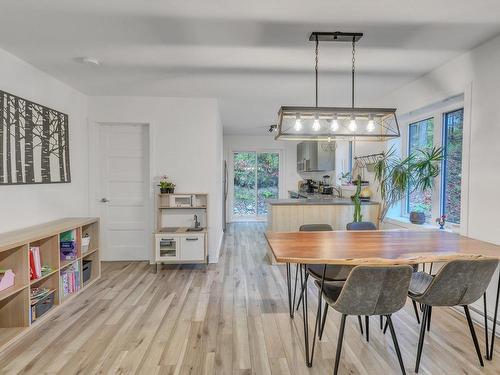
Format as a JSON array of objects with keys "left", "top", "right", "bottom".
[{"left": 333, "top": 265, "right": 413, "bottom": 315}]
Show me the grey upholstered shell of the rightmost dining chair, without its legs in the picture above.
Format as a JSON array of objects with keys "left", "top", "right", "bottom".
[{"left": 417, "top": 258, "right": 498, "bottom": 306}]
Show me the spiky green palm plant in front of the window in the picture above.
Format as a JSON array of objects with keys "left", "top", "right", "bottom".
[{"left": 374, "top": 147, "right": 443, "bottom": 224}]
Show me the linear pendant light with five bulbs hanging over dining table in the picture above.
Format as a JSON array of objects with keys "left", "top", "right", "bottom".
[{"left": 275, "top": 32, "right": 400, "bottom": 141}]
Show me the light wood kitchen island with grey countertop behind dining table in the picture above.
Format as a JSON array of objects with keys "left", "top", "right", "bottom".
[{"left": 267, "top": 194, "right": 380, "bottom": 232}]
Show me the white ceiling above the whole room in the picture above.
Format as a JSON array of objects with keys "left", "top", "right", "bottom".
[{"left": 0, "top": 0, "right": 500, "bottom": 134}]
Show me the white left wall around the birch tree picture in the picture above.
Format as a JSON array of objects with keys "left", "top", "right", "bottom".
[{"left": 0, "top": 49, "right": 88, "bottom": 229}]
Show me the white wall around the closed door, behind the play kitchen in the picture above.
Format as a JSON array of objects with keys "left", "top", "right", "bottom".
[{"left": 89, "top": 97, "right": 222, "bottom": 262}]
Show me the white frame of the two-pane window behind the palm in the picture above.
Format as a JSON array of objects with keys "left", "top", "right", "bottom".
[{"left": 400, "top": 100, "right": 468, "bottom": 231}]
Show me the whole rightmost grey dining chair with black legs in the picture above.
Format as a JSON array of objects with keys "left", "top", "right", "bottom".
[{"left": 408, "top": 259, "right": 498, "bottom": 372}]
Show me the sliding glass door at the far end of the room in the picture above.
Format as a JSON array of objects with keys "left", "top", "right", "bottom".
[{"left": 232, "top": 151, "right": 280, "bottom": 219}]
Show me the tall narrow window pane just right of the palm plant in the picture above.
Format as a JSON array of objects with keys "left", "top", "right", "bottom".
[{"left": 441, "top": 109, "right": 464, "bottom": 224}]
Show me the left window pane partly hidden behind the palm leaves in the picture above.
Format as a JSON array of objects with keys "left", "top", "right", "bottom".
[{"left": 406, "top": 118, "right": 434, "bottom": 217}]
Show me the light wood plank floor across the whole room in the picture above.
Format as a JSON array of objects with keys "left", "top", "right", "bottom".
[{"left": 0, "top": 223, "right": 500, "bottom": 375}]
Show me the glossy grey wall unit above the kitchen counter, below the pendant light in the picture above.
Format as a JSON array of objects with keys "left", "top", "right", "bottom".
[{"left": 297, "top": 141, "right": 336, "bottom": 173}]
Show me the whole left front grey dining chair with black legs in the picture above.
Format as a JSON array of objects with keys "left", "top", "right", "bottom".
[{"left": 316, "top": 266, "right": 413, "bottom": 375}]
